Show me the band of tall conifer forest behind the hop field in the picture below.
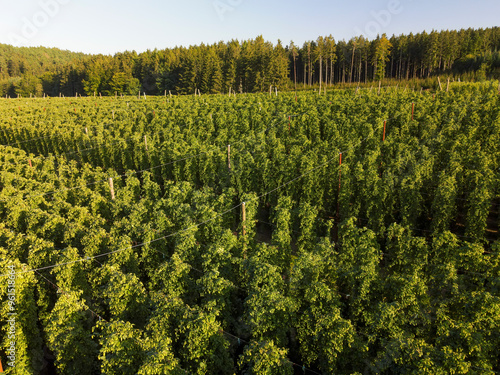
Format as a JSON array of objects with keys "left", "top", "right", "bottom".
[{"left": 0, "top": 27, "right": 500, "bottom": 98}]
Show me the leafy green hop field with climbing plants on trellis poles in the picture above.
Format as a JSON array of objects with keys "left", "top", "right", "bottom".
[{"left": 0, "top": 81, "right": 500, "bottom": 375}]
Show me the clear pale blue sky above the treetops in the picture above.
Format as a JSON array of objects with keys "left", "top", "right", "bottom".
[{"left": 0, "top": 0, "right": 500, "bottom": 54}]
